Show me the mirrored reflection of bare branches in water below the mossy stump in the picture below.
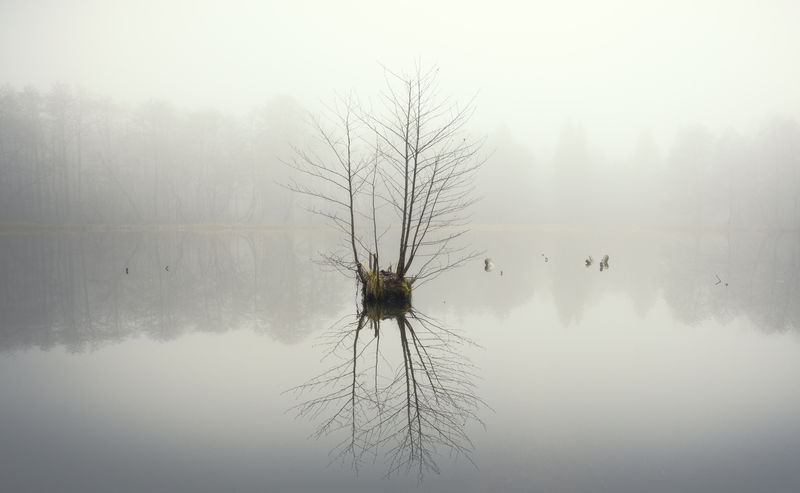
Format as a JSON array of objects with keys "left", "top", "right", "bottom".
[{"left": 292, "top": 306, "right": 485, "bottom": 480}]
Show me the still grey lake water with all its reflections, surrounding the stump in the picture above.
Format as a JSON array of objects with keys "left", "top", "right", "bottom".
[{"left": 0, "top": 229, "right": 800, "bottom": 492}]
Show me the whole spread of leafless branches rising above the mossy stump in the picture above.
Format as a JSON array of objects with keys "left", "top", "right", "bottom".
[{"left": 289, "top": 68, "right": 484, "bottom": 281}]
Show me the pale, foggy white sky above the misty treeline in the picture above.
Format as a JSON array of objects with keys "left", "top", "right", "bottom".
[{"left": 0, "top": 0, "right": 800, "bottom": 154}]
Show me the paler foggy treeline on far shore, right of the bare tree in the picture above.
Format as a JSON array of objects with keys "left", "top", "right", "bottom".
[{"left": 476, "top": 118, "right": 800, "bottom": 230}]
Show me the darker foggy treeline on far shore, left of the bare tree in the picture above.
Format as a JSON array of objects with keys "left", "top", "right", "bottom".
[{"left": 0, "top": 85, "right": 303, "bottom": 224}]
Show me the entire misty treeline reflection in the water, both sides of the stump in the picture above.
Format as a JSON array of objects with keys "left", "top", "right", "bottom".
[{"left": 0, "top": 231, "right": 800, "bottom": 351}]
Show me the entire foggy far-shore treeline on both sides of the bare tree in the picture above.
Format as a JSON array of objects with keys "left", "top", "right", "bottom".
[{"left": 0, "top": 85, "right": 800, "bottom": 230}]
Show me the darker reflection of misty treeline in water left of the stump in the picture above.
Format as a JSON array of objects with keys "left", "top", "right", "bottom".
[{"left": 0, "top": 232, "right": 347, "bottom": 350}]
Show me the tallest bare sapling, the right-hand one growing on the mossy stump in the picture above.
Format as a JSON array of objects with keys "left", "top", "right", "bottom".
[{"left": 362, "top": 67, "right": 484, "bottom": 279}]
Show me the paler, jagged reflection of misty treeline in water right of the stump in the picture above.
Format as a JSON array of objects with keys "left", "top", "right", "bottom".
[{"left": 424, "top": 230, "right": 800, "bottom": 332}]
